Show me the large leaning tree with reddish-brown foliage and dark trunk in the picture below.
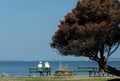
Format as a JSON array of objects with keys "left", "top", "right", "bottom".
[{"left": 51, "top": 0, "right": 120, "bottom": 76}]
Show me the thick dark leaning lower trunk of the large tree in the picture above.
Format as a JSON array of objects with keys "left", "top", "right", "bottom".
[{"left": 98, "top": 61, "right": 120, "bottom": 77}]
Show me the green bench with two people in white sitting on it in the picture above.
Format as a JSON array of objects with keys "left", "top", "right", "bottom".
[{"left": 29, "top": 68, "right": 51, "bottom": 76}]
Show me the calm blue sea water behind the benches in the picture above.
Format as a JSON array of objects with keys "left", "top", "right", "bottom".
[{"left": 0, "top": 61, "right": 120, "bottom": 76}]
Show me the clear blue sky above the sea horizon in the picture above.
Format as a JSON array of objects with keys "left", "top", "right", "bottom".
[{"left": 0, "top": 0, "right": 120, "bottom": 61}]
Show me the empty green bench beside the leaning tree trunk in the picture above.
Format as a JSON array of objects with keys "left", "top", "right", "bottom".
[{"left": 74, "top": 67, "right": 97, "bottom": 77}]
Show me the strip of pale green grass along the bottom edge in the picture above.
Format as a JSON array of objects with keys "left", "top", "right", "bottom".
[{"left": 0, "top": 76, "right": 119, "bottom": 81}]
